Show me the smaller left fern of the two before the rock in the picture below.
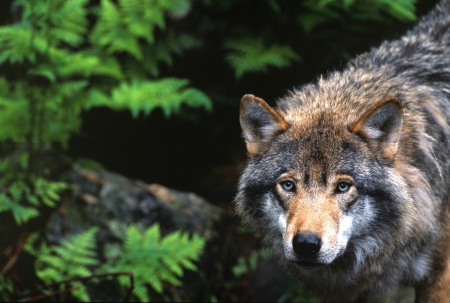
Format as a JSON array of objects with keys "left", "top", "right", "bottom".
[{"left": 32, "top": 227, "right": 99, "bottom": 302}]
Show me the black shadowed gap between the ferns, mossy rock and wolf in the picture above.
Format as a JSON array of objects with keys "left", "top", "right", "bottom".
[{"left": 65, "top": 0, "right": 442, "bottom": 203}]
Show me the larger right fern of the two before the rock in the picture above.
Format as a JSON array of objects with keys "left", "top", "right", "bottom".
[{"left": 104, "top": 224, "right": 204, "bottom": 302}]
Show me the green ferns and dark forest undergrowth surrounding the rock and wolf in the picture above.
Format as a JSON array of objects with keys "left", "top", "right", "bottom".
[{"left": 0, "top": 0, "right": 436, "bottom": 301}]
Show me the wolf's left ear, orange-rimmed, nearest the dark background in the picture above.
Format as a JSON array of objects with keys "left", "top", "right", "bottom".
[{"left": 239, "top": 95, "right": 289, "bottom": 156}]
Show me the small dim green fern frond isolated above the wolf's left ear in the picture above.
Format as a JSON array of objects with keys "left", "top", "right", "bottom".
[{"left": 225, "top": 39, "right": 300, "bottom": 78}]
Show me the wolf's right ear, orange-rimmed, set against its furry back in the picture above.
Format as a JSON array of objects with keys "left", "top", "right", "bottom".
[{"left": 350, "top": 98, "right": 403, "bottom": 161}]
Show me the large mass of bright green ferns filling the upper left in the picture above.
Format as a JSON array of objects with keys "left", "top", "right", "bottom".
[{"left": 0, "top": 0, "right": 211, "bottom": 223}]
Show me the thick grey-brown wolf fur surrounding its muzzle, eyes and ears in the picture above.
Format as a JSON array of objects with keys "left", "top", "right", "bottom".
[{"left": 235, "top": 0, "right": 450, "bottom": 301}]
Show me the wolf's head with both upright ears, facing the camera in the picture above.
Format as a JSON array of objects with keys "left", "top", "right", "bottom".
[{"left": 236, "top": 95, "right": 407, "bottom": 270}]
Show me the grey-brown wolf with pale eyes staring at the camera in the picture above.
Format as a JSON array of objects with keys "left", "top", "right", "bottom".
[{"left": 234, "top": 0, "right": 450, "bottom": 302}]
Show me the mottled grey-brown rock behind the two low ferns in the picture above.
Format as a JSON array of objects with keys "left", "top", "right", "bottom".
[{"left": 46, "top": 165, "right": 226, "bottom": 300}]
